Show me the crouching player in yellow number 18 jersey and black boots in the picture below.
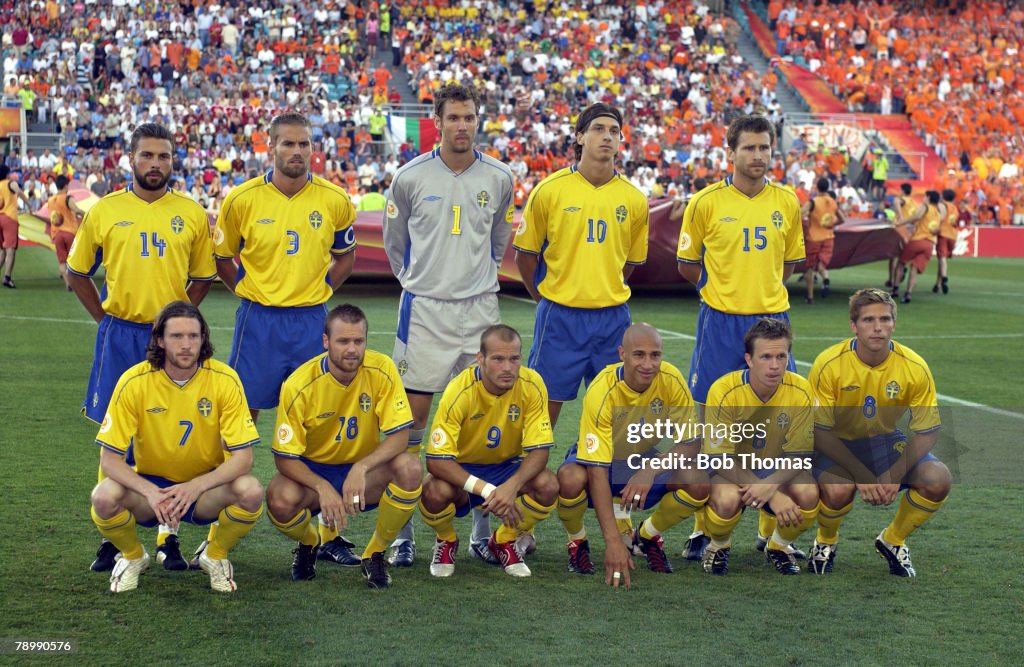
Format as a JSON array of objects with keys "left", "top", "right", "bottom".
[{"left": 266, "top": 304, "right": 422, "bottom": 589}]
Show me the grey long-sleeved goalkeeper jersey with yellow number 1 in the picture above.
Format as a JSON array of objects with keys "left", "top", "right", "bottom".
[{"left": 384, "top": 149, "right": 514, "bottom": 299}]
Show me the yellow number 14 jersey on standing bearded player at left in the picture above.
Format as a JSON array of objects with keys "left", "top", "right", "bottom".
[{"left": 68, "top": 187, "right": 217, "bottom": 323}]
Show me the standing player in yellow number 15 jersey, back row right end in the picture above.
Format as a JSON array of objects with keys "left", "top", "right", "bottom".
[{"left": 676, "top": 116, "right": 805, "bottom": 560}]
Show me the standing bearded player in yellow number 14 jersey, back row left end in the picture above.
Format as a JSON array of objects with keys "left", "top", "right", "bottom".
[{"left": 68, "top": 123, "right": 217, "bottom": 572}]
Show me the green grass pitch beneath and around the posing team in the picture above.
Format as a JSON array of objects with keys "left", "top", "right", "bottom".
[{"left": 0, "top": 248, "right": 1024, "bottom": 665}]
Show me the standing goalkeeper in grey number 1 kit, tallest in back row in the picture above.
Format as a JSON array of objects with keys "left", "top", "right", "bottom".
[{"left": 384, "top": 84, "right": 515, "bottom": 567}]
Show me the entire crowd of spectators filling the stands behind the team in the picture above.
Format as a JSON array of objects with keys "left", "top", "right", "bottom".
[{"left": 0, "top": 0, "right": 1024, "bottom": 223}]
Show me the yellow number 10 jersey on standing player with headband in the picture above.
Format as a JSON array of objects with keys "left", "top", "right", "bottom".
[{"left": 512, "top": 166, "right": 649, "bottom": 308}]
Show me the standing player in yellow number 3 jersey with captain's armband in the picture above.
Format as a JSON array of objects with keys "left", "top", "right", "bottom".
[{"left": 214, "top": 113, "right": 359, "bottom": 567}]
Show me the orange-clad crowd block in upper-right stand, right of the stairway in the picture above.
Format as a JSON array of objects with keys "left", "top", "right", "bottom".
[{"left": 767, "top": 0, "right": 1024, "bottom": 224}]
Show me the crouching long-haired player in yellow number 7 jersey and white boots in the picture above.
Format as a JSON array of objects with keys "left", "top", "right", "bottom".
[{"left": 92, "top": 301, "right": 263, "bottom": 593}]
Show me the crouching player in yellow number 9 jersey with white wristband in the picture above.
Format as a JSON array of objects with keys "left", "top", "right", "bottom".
[{"left": 420, "top": 325, "right": 558, "bottom": 577}]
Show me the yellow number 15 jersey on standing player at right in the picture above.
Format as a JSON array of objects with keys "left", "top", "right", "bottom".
[{"left": 676, "top": 176, "right": 805, "bottom": 315}]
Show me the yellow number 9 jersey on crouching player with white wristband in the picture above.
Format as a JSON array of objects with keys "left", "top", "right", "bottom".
[{"left": 427, "top": 366, "right": 554, "bottom": 463}]
